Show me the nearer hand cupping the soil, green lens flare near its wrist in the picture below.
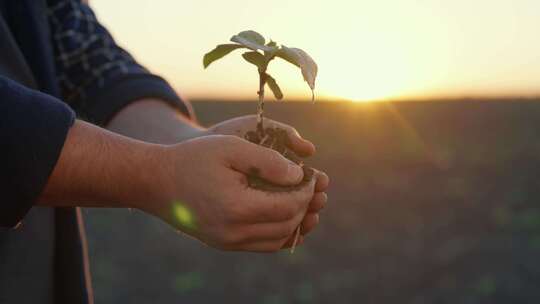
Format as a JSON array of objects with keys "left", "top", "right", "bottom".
[{"left": 141, "top": 135, "right": 318, "bottom": 252}]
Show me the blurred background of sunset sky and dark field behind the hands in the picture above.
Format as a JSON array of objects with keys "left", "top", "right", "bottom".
[{"left": 84, "top": 0, "right": 540, "bottom": 304}]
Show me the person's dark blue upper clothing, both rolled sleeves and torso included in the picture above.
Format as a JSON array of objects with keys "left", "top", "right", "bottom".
[{"left": 0, "top": 0, "right": 190, "bottom": 303}]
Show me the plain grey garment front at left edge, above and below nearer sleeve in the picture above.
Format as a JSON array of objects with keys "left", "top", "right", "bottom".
[{"left": 0, "top": 2, "right": 55, "bottom": 303}]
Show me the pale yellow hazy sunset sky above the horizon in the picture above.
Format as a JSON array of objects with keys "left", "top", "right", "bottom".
[{"left": 90, "top": 0, "right": 540, "bottom": 100}]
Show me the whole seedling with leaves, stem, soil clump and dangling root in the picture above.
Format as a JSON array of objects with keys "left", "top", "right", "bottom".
[{"left": 203, "top": 31, "right": 318, "bottom": 253}]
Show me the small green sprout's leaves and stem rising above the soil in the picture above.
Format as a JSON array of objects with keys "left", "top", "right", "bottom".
[{"left": 203, "top": 31, "right": 318, "bottom": 128}]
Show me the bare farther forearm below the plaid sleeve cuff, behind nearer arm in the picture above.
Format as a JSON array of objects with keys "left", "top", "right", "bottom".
[{"left": 107, "top": 99, "right": 205, "bottom": 144}]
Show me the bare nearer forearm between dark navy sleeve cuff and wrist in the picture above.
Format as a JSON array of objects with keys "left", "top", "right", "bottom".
[{"left": 37, "top": 121, "right": 161, "bottom": 207}]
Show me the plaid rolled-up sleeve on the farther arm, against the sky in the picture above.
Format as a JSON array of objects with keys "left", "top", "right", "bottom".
[{"left": 48, "top": 0, "right": 193, "bottom": 125}]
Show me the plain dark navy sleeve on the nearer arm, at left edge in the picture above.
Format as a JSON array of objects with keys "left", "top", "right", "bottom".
[{"left": 0, "top": 76, "right": 75, "bottom": 227}]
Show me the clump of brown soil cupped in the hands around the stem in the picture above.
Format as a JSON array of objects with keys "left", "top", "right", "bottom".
[{"left": 244, "top": 124, "right": 314, "bottom": 192}]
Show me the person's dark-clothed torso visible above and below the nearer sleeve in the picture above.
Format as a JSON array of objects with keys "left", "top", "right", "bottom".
[{"left": 0, "top": 0, "right": 88, "bottom": 304}]
